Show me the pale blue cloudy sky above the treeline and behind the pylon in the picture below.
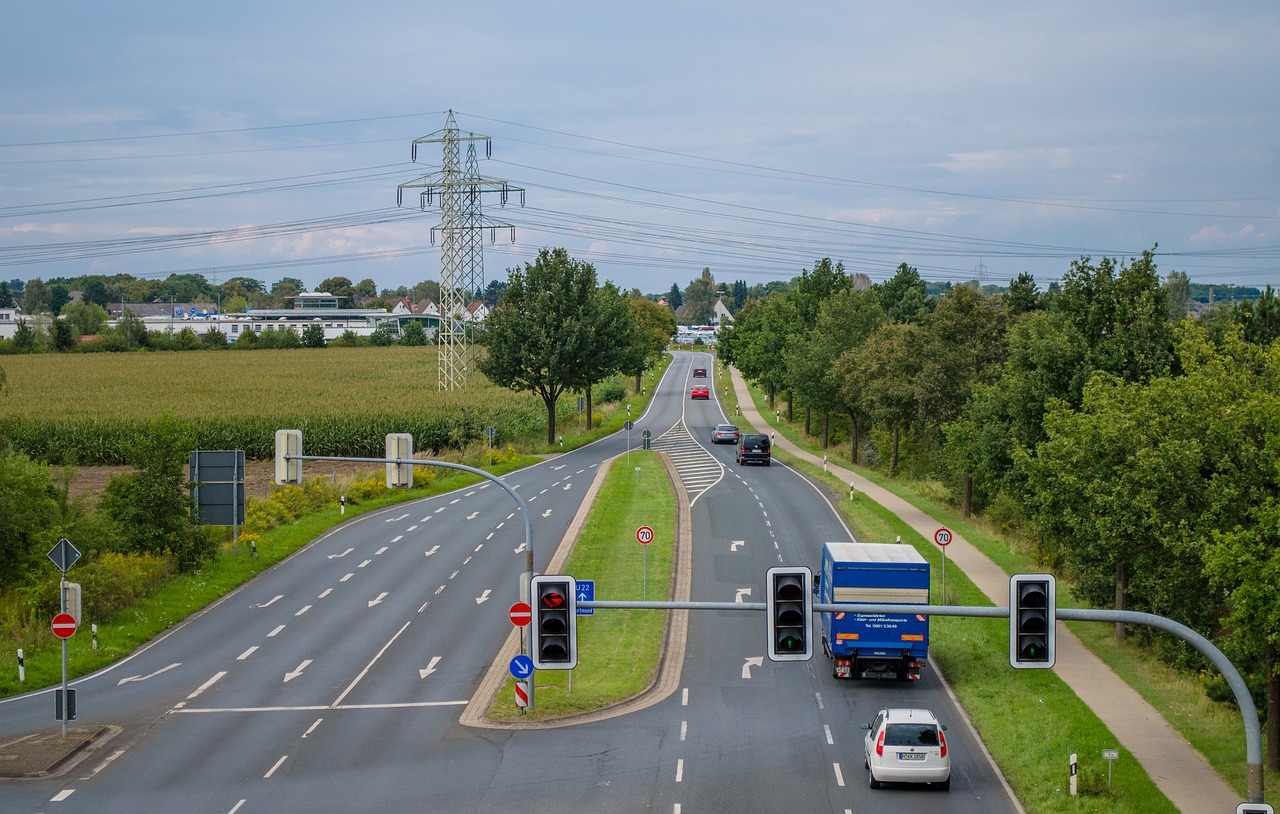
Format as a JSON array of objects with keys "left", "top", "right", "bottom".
[{"left": 0, "top": 0, "right": 1280, "bottom": 299}]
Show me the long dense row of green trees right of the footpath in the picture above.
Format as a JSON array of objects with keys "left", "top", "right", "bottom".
[{"left": 719, "top": 252, "right": 1280, "bottom": 768}]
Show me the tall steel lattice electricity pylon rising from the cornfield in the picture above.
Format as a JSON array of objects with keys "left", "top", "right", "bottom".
[{"left": 396, "top": 110, "right": 525, "bottom": 390}]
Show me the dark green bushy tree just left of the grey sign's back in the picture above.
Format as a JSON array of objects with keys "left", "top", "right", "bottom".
[{"left": 101, "top": 413, "right": 215, "bottom": 571}]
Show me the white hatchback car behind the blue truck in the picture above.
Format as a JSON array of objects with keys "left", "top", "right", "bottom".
[{"left": 863, "top": 709, "right": 951, "bottom": 791}]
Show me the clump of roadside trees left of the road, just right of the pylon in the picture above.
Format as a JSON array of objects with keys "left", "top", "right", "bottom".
[{"left": 479, "top": 248, "right": 676, "bottom": 444}]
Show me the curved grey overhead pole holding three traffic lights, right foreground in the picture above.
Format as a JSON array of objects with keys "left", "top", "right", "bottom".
[{"left": 577, "top": 599, "right": 1263, "bottom": 802}]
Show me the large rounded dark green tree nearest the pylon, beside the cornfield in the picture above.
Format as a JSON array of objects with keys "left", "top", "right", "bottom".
[{"left": 479, "top": 248, "right": 609, "bottom": 444}]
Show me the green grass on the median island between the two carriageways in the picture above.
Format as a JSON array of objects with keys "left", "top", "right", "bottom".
[{"left": 486, "top": 452, "right": 676, "bottom": 719}]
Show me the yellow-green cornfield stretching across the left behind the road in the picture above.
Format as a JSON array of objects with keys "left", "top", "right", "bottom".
[{"left": 0, "top": 347, "right": 560, "bottom": 466}]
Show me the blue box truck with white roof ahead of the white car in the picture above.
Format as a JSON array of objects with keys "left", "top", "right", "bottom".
[{"left": 814, "top": 543, "right": 929, "bottom": 681}]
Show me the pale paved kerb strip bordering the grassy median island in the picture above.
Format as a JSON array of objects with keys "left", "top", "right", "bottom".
[{"left": 458, "top": 452, "right": 694, "bottom": 730}]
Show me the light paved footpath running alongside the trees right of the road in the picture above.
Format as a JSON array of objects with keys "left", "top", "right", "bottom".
[{"left": 731, "top": 369, "right": 1245, "bottom": 814}]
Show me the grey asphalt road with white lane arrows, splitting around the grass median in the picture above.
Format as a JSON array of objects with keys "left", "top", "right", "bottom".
[{"left": 0, "top": 353, "right": 1016, "bottom": 814}]
